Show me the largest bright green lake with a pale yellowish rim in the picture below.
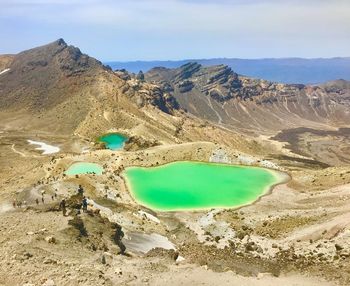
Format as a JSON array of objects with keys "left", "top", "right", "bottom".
[{"left": 125, "top": 161, "right": 286, "bottom": 211}]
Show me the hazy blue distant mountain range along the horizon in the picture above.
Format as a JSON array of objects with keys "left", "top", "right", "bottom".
[{"left": 105, "top": 57, "right": 350, "bottom": 84}]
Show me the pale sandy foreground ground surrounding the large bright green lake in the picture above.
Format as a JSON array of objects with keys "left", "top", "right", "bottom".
[{"left": 0, "top": 123, "right": 350, "bottom": 286}]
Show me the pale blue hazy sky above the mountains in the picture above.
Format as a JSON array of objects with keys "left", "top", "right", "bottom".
[{"left": 0, "top": 0, "right": 350, "bottom": 61}]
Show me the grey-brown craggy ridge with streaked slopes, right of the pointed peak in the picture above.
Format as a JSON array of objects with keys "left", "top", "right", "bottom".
[{"left": 145, "top": 63, "right": 350, "bottom": 133}]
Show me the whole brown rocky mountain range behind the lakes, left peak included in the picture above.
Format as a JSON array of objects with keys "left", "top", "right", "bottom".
[{"left": 0, "top": 39, "right": 350, "bottom": 139}]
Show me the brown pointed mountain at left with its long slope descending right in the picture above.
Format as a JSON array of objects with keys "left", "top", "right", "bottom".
[{"left": 0, "top": 39, "right": 262, "bottom": 190}]
